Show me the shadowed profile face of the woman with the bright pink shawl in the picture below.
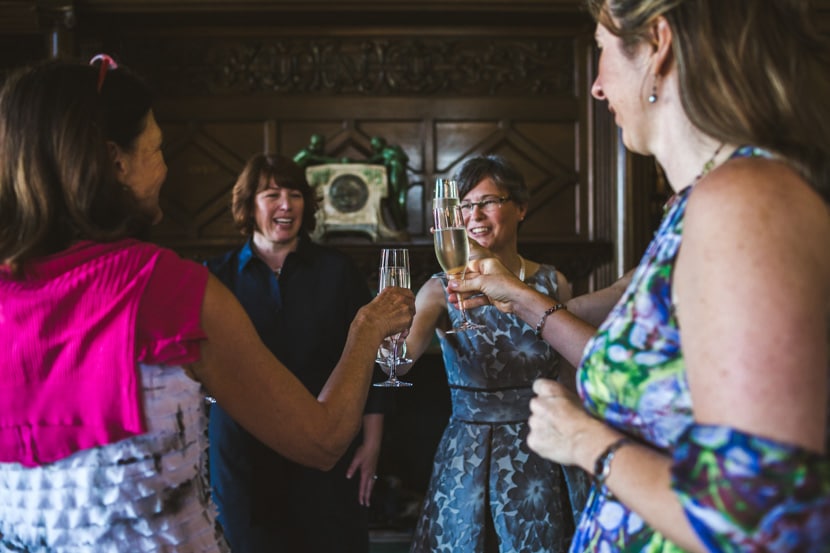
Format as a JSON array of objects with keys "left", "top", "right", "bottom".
[{"left": 111, "top": 111, "right": 167, "bottom": 223}]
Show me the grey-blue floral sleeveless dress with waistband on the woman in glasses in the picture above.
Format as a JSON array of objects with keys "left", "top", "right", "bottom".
[{"left": 411, "top": 265, "right": 588, "bottom": 553}]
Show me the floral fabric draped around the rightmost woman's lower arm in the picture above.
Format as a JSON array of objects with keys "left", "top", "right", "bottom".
[{"left": 672, "top": 425, "right": 830, "bottom": 552}]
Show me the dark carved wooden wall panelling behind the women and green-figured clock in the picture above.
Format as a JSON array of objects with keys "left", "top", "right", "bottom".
[{"left": 0, "top": 0, "right": 612, "bottom": 291}]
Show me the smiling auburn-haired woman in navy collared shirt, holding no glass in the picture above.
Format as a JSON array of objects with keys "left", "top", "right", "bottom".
[{"left": 207, "top": 154, "right": 387, "bottom": 553}]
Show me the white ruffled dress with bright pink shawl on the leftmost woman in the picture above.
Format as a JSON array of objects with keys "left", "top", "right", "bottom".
[{"left": 0, "top": 240, "right": 228, "bottom": 553}]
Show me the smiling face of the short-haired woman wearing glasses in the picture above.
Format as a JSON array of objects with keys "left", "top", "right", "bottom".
[{"left": 461, "top": 177, "right": 527, "bottom": 252}]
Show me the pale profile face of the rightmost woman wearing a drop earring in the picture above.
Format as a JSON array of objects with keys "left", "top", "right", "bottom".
[{"left": 591, "top": 24, "right": 654, "bottom": 154}]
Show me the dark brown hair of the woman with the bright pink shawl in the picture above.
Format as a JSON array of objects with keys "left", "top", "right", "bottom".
[{"left": 0, "top": 60, "right": 157, "bottom": 274}]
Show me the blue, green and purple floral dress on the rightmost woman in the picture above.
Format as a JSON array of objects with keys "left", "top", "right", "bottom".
[{"left": 571, "top": 147, "right": 830, "bottom": 553}]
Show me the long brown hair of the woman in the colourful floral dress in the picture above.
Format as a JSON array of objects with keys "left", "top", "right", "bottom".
[{"left": 587, "top": 0, "right": 830, "bottom": 201}]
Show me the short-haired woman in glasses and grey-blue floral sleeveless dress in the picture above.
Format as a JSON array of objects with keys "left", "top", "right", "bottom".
[{"left": 407, "top": 156, "right": 588, "bottom": 553}]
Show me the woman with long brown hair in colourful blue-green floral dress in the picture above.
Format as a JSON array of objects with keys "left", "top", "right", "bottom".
[{"left": 453, "top": 0, "right": 830, "bottom": 552}]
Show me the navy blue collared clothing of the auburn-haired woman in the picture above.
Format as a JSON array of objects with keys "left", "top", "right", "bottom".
[{"left": 206, "top": 237, "right": 390, "bottom": 553}]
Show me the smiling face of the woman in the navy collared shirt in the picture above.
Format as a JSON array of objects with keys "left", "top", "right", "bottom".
[{"left": 254, "top": 178, "right": 305, "bottom": 245}]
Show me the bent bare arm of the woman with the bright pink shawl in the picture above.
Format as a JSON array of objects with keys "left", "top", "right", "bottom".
[{"left": 191, "top": 275, "right": 414, "bottom": 470}]
